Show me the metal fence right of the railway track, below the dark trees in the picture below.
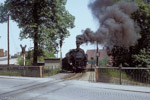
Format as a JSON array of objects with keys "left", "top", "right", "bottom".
[{"left": 96, "top": 67, "right": 150, "bottom": 86}]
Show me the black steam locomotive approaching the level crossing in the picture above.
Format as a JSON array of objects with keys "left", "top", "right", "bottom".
[{"left": 62, "top": 47, "right": 87, "bottom": 72}]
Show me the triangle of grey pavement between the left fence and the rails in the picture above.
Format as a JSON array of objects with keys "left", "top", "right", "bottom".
[{"left": 0, "top": 76, "right": 54, "bottom": 94}]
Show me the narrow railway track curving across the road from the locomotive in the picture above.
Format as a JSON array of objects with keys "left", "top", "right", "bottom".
[{"left": 0, "top": 73, "right": 83, "bottom": 100}]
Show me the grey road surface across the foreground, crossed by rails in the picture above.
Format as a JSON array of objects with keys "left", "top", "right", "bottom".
[{"left": 0, "top": 74, "right": 150, "bottom": 100}]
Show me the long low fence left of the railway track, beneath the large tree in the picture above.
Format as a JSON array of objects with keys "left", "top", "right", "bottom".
[{"left": 0, "top": 65, "right": 61, "bottom": 77}]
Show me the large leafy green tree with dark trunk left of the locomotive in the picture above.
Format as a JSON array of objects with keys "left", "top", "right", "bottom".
[{"left": 0, "top": 0, "right": 74, "bottom": 65}]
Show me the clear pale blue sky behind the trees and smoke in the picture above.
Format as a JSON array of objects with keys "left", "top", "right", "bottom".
[{"left": 0, "top": 0, "right": 101, "bottom": 57}]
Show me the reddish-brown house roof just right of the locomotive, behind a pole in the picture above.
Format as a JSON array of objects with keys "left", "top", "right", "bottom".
[{"left": 86, "top": 49, "right": 108, "bottom": 60}]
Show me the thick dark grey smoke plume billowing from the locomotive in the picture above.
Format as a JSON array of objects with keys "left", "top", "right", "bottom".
[{"left": 76, "top": 0, "right": 140, "bottom": 48}]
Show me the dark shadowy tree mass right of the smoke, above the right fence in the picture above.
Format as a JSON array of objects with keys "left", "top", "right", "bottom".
[{"left": 109, "top": 0, "right": 150, "bottom": 67}]
